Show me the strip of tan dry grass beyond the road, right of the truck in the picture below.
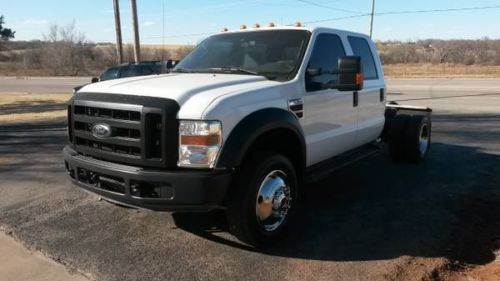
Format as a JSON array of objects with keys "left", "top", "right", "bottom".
[{"left": 384, "top": 64, "right": 500, "bottom": 78}]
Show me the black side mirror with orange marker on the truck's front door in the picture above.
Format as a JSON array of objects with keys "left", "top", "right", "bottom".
[{"left": 335, "top": 56, "right": 363, "bottom": 91}]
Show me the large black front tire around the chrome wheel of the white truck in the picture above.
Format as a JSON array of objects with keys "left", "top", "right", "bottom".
[{"left": 227, "top": 153, "right": 299, "bottom": 246}]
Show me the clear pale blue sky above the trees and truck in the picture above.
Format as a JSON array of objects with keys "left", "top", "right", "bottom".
[{"left": 0, "top": 0, "right": 500, "bottom": 44}]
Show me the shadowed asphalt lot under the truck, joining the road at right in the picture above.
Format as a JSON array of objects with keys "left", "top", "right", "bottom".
[{"left": 0, "top": 77, "right": 500, "bottom": 280}]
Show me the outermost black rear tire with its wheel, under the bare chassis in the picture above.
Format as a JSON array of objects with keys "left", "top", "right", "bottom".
[{"left": 404, "top": 115, "right": 431, "bottom": 163}]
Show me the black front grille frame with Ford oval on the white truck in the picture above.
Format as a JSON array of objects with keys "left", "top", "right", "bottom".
[{"left": 70, "top": 92, "right": 180, "bottom": 168}]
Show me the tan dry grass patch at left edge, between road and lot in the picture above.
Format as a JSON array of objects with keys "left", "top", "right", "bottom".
[{"left": 0, "top": 93, "right": 71, "bottom": 124}]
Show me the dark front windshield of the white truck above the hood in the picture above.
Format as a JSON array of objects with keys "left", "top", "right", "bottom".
[{"left": 174, "top": 30, "right": 310, "bottom": 80}]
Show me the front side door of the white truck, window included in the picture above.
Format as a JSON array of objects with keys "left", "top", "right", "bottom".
[{"left": 302, "top": 33, "right": 357, "bottom": 165}]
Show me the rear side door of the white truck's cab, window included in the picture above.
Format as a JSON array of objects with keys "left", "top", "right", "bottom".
[{"left": 347, "top": 36, "right": 385, "bottom": 146}]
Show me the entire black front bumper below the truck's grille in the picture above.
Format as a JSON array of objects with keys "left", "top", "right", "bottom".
[{"left": 63, "top": 146, "right": 231, "bottom": 211}]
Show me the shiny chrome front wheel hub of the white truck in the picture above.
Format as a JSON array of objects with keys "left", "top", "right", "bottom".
[{"left": 255, "top": 170, "right": 292, "bottom": 231}]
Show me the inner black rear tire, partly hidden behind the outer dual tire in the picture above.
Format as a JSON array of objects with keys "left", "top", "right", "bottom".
[{"left": 389, "top": 114, "right": 411, "bottom": 162}]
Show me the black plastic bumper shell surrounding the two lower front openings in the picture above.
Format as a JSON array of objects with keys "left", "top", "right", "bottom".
[{"left": 63, "top": 146, "right": 232, "bottom": 211}]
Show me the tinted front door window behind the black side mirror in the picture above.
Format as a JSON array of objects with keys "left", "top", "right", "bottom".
[{"left": 306, "top": 33, "right": 345, "bottom": 92}]
